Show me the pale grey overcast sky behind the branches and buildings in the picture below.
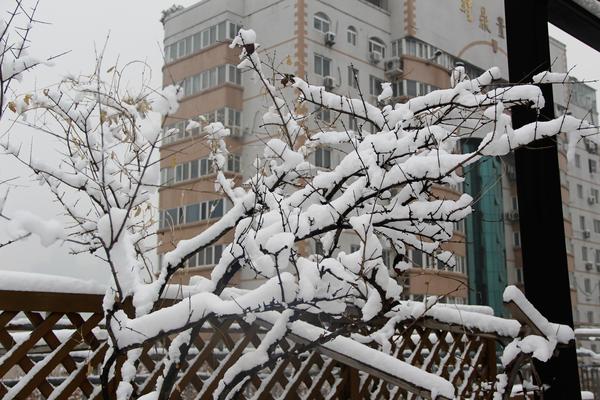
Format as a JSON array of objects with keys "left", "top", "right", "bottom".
[{"left": 0, "top": 0, "right": 600, "bottom": 279}]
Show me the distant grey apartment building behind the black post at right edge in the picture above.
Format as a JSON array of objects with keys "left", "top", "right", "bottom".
[{"left": 502, "top": 38, "right": 600, "bottom": 338}]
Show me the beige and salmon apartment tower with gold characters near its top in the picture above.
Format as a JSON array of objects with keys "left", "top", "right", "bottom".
[{"left": 159, "top": 0, "right": 506, "bottom": 303}]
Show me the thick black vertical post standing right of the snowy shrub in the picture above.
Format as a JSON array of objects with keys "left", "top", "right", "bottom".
[{"left": 504, "top": 0, "right": 581, "bottom": 400}]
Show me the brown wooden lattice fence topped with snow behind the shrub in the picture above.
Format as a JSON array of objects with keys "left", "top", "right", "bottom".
[{"left": 0, "top": 276, "right": 572, "bottom": 399}]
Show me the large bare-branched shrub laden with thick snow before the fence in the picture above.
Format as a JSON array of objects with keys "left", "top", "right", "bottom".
[{"left": 4, "top": 23, "right": 597, "bottom": 398}]
